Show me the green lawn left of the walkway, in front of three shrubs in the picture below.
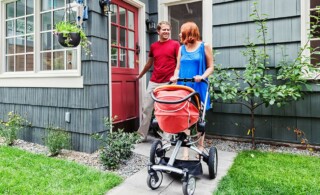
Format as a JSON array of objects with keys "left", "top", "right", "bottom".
[{"left": 0, "top": 146, "right": 122, "bottom": 194}]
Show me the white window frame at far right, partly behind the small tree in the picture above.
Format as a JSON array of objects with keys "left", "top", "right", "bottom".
[{"left": 300, "top": 0, "right": 320, "bottom": 80}]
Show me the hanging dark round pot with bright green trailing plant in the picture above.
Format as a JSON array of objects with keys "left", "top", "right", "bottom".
[{"left": 55, "top": 21, "right": 91, "bottom": 55}]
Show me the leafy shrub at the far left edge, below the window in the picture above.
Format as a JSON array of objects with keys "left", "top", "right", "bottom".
[{"left": 0, "top": 112, "right": 31, "bottom": 146}]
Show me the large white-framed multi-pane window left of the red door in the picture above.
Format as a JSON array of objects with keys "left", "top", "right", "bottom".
[{"left": 0, "top": 0, "right": 82, "bottom": 87}]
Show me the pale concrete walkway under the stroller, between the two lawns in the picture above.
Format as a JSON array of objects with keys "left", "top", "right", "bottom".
[{"left": 107, "top": 137, "right": 237, "bottom": 195}]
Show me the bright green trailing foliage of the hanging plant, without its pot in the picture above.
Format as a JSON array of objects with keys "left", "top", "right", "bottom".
[{"left": 55, "top": 21, "right": 91, "bottom": 55}]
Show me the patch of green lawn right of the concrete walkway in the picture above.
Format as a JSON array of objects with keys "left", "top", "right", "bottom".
[{"left": 214, "top": 151, "right": 320, "bottom": 195}]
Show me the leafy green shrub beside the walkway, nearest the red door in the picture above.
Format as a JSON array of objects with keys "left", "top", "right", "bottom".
[{"left": 93, "top": 118, "right": 139, "bottom": 169}]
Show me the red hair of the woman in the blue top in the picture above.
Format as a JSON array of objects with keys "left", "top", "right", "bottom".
[{"left": 181, "top": 22, "right": 200, "bottom": 45}]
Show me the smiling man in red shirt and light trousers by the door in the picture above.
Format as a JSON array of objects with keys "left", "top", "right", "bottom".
[{"left": 137, "top": 21, "right": 180, "bottom": 142}]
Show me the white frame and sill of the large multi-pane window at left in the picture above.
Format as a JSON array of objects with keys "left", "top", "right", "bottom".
[{"left": 0, "top": 0, "right": 83, "bottom": 88}]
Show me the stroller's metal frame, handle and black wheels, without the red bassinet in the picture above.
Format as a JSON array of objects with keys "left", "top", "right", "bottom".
[{"left": 147, "top": 78, "right": 218, "bottom": 195}]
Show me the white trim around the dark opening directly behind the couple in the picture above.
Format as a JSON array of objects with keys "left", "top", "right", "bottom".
[{"left": 158, "top": 0, "right": 212, "bottom": 45}]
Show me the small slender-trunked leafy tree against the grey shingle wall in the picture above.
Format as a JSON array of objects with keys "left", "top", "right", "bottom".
[{"left": 209, "top": 2, "right": 316, "bottom": 148}]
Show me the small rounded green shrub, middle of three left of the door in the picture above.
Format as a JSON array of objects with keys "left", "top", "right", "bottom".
[{"left": 45, "top": 126, "right": 71, "bottom": 156}]
